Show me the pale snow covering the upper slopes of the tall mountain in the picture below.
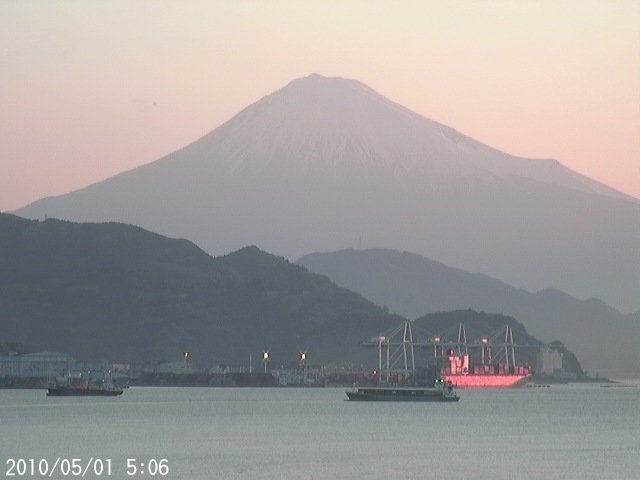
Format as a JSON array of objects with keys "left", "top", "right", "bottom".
[{"left": 179, "top": 75, "right": 624, "bottom": 198}]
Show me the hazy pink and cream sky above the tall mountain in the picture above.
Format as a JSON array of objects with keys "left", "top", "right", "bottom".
[{"left": 0, "top": 0, "right": 640, "bottom": 211}]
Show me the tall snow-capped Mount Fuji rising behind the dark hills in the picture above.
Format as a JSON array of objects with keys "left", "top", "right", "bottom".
[{"left": 14, "top": 71, "right": 640, "bottom": 311}]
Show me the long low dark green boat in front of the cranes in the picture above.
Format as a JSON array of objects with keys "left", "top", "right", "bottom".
[{"left": 345, "top": 379, "right": 460, "bottom": 402}]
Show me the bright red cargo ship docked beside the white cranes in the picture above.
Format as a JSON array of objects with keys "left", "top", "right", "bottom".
[{"left": 440, "top": 354, "right": 532, "bottom": 388}]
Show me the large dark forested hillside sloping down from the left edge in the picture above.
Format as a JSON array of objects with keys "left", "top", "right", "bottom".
[{"left": 0, "top": 214, "right": 402, "bottom": 367}]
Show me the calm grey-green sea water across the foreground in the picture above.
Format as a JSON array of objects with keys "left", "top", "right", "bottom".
[{"left": 0, "top": 385, "right": 640, "bottom": 480}]
